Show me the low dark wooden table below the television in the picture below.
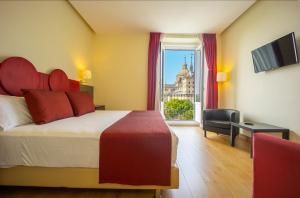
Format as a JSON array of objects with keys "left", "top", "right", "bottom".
[{"left": 230, "top": 122, "right": 290, "bottom": 158}]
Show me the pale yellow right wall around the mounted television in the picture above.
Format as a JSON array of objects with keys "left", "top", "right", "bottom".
[{"left": 220, "top": 1, "right": 300, "bottom": 141}]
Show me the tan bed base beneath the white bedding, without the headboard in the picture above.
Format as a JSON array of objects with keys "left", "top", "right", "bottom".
[{"left": 0, "top": 166, "right": 179, "bottom": 198}]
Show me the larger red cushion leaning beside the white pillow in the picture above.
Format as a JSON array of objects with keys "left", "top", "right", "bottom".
[{"left": 24, "top": 90, "right": 74, "bottom": 124}]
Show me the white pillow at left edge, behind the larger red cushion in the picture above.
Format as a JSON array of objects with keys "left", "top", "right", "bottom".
[{"left": 0, "top": 95, "right": 32, "bottom": 131}]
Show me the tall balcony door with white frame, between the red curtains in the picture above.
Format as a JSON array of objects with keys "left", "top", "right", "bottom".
[{"left": 160, "top": 44, "right": 203, "bottom": 123}]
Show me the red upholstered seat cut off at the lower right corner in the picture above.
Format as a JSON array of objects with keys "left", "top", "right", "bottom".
[{"left": 253, "top": 133, "right": 300, "bottom": 198}]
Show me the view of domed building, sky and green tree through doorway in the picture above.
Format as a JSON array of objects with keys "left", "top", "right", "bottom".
[{"left": 163, "top": 50, "right": 195, "bottom": 120}]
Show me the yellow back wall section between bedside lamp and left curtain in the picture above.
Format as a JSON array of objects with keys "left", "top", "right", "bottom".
[{"left": 93, "top": 33, "right": 149, "bottom": 110}]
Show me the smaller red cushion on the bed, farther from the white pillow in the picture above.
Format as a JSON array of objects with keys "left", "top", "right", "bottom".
[{"left": 66, "top": 91, "right": 95, "bottom": 116}]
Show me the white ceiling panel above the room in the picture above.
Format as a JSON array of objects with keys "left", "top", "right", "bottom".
[{"left": 70, "top": 0, "right": 255, "bottom": 33}]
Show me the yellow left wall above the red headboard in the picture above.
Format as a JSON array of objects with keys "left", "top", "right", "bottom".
[{"left": 0, "top": 1, "right": 94, "bottom": 79}]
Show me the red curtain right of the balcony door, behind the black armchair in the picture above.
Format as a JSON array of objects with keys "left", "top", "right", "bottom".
[{"left": 203, "top": 34, "right": 218, "bottom": 109}]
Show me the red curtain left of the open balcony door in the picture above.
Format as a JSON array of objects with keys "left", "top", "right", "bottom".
[{"left": 147, "top": 32, "right": 161, "bottom": 110}]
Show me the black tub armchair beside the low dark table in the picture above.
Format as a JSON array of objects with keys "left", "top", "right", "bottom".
[{"left": 203, "top": 109, "right": 240, "bottom": 140}]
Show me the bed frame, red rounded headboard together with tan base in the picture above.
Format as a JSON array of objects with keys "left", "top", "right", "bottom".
[{"left": 0, "top": 57, "right": 179, "bottom": 198}]
